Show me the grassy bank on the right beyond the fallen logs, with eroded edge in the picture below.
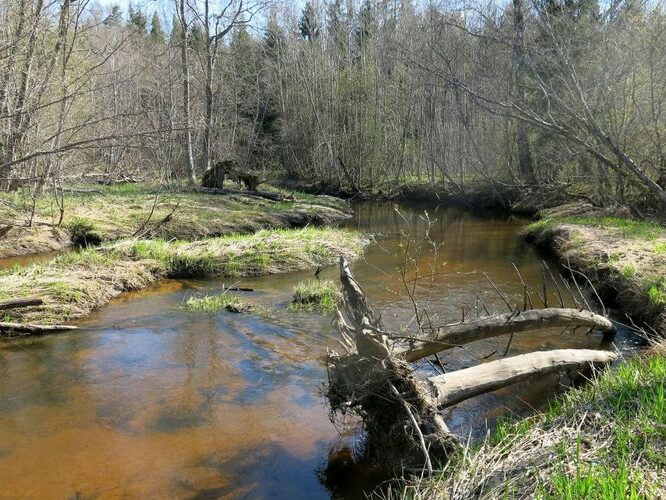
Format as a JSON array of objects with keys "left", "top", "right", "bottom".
[{"left": 526, "top": 205, "right": 666, "bottom": 335}]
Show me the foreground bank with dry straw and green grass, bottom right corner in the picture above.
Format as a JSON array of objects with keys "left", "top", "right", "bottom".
[{"left": 393, "top": 344, "right": 666, "bottom": 500}]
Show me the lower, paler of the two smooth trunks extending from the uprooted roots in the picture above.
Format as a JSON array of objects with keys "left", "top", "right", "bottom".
[{"left": 428, "top": 349, "right": 617, "bottom": 408}]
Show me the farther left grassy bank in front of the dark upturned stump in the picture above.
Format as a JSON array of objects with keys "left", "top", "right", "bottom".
[{"left": 0, "top": 184, "right": 348, "bottom": 258}]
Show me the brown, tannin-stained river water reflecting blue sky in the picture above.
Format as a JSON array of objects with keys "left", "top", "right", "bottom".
[{"left": 0, "top": 203, "right": 632, "bottom": 499}]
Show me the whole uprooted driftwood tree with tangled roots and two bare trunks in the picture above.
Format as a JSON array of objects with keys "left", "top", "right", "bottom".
[{"left": 327, "top": 258, "right": 616, "bottom": 472}]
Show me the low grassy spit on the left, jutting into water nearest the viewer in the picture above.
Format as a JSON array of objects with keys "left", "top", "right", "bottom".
[{"left": 0, "top": 228, "right": 365, "bottom": 324}]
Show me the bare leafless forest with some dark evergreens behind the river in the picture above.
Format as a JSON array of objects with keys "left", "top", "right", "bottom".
[{"left": 0, "top": 0, "right": 666, "bottom": 214}]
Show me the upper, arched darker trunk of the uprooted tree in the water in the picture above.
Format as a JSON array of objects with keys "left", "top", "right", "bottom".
[{"left": 402, "top": 308, "right": 613, "bottom": 362}]
